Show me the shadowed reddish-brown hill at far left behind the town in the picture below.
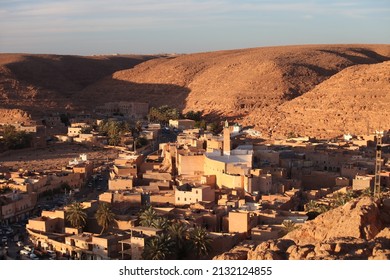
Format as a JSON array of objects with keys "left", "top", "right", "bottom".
[{"left": 0, "top": 54, "right": 159, "bottom": 118}]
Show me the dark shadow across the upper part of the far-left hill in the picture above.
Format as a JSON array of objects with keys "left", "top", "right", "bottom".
[{"left": 7, "top": 55, "right": 158, "bottom": 97}]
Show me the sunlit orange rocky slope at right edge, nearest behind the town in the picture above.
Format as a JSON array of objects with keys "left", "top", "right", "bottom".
[{"left": 278, "top": 62, "right": 390, "bottom": 139}]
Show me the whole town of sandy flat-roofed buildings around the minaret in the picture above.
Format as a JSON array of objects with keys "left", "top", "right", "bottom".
[{"left": 0, "top": 101, "right": 390, "bottom": 260}]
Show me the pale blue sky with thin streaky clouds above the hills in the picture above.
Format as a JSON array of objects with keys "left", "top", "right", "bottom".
[{"left": 0, "top": 0, "right": 390, "bottom": 55}]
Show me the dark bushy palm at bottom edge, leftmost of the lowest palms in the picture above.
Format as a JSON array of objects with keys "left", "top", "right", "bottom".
[{"left": 142, "top": 233, "right": 173, "bottom": 260}]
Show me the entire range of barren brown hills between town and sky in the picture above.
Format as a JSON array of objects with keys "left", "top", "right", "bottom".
[{"left": 0, "top": 45, "right": 390, "bottom": 137}]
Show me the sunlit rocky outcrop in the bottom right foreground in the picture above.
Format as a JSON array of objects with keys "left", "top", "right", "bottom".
[{"left": 214, "top": 197, "right": 390, "bottom": 260}]
